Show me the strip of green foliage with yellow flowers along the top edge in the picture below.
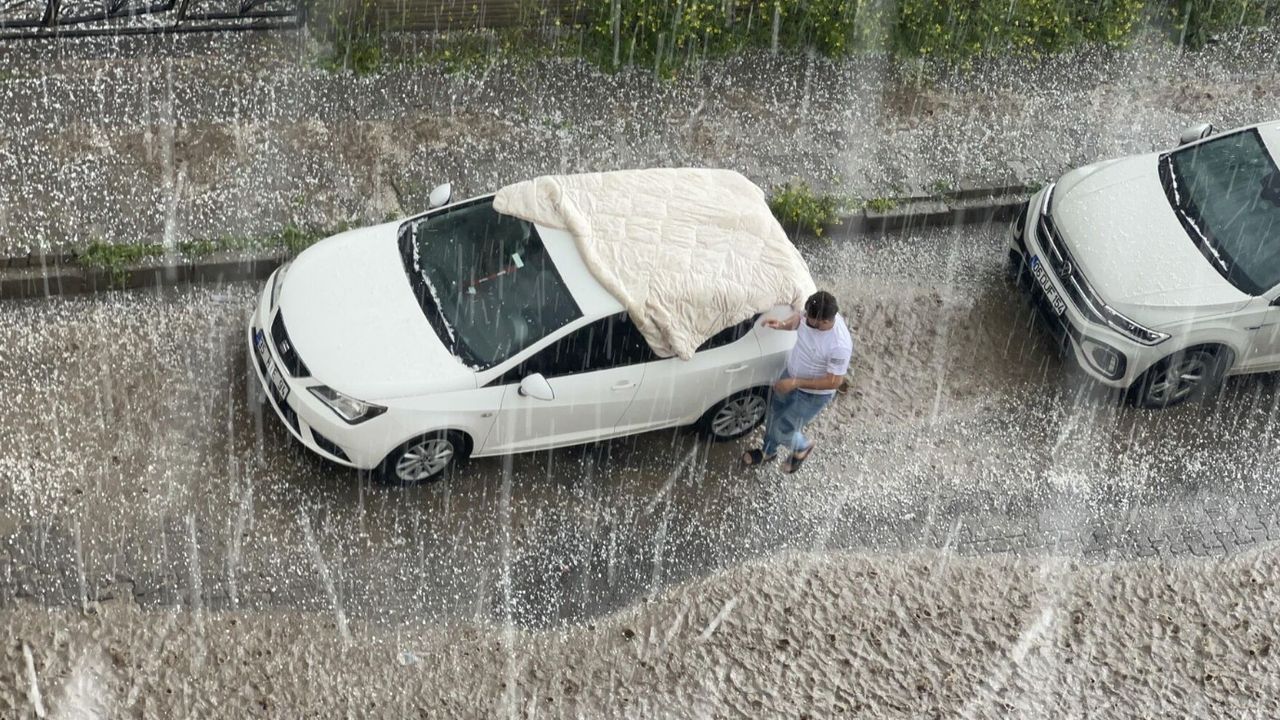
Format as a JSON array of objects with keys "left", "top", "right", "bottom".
[{"left": 311, "top": 0, "right": 1280, "bottom": 77}]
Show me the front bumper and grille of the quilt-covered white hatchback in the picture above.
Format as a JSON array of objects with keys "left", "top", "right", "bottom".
[{"left": 246, "top": 273, "right": 381, "bottom": 469}]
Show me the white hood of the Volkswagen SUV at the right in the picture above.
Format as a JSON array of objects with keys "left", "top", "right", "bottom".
[{"left": 1051, "top": 154, "right": 1249, "bottom": 327}]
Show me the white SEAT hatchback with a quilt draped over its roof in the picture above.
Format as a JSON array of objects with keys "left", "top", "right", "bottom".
[{"left": 248, "top": 186, "right": 795, "bottom": 483}]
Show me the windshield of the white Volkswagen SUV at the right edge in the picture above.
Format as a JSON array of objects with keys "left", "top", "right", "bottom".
[{"left": 1160, "top": 129, "right": 1280, "bottom": 295}]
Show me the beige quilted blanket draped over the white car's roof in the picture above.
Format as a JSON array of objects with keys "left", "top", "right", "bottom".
[{"left": 494, "top": 168, "right": 814, "bottom": 360}]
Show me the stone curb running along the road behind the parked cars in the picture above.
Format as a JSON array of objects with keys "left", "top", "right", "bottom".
[{"left": 0, "top": 184, "right": 1029, "bottom": 300}]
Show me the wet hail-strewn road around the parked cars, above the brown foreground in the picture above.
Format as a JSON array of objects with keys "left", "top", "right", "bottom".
[{"left": 0, "top": 220, "right": 1280, "bottom": 626}]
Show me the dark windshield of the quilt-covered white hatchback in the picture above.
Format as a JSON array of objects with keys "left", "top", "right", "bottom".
[{"left": 401, "top": 199, "right": 582, "bottom": 369}]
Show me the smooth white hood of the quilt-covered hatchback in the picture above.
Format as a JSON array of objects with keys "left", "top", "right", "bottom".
[{"left": 279, "top": 223, "right": 476, "bottom": 401}]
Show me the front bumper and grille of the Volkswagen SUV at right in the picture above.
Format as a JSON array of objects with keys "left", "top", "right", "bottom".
[{"left": 1009, "top": 188, "right": 1158, "bottom": 388}]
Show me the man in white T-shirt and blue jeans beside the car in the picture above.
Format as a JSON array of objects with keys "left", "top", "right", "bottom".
[{"left": 742, "top": 291, "right": 854, "bottom": 474}]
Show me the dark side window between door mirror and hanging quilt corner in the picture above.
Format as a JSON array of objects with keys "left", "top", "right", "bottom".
[{"left": 490, "top": 313, "right": 658, "bottom": 384}]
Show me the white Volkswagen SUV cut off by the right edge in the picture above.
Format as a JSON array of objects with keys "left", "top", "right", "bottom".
[{"left": 1009, "top": 122, "right": 1280, "bottom": 407}]
